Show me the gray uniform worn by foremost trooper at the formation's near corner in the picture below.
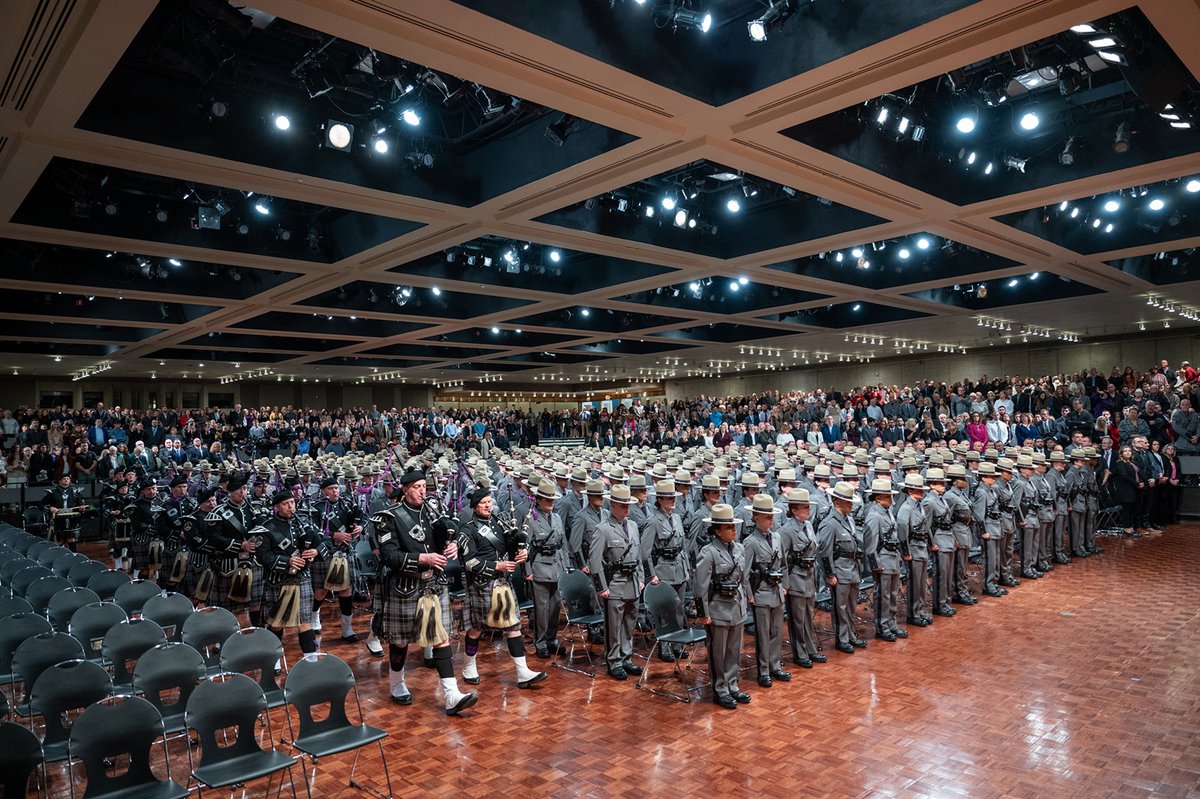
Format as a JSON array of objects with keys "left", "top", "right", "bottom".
[{"left": 691, "top": 539, "right": 750, "bottom": 696}]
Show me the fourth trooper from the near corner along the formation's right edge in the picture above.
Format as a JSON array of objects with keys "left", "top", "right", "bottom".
[{"left": 817, "top": 481, "right": 866, "bottom": 654}]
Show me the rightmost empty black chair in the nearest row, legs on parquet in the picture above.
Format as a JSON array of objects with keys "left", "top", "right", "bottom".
[{"left": 283, "top": 651, "right": 392, "bottom": 797}]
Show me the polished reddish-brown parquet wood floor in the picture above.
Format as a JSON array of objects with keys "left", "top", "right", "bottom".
[{"left": 37, "top": 524, "right": 1200, "bottom": 799}]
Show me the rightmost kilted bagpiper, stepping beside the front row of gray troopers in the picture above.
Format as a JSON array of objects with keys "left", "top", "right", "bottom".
[{"left": 457, "top": 488, "right": 547, "bottom": 689}]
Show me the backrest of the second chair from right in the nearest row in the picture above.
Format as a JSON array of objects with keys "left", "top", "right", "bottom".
[{"left": 187, "top": 674, "right": 266, "bottom": 767}]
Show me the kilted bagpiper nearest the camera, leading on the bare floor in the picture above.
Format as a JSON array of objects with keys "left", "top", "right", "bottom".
[{"left": 371, "top": 469, "right": 479, "bottom": 716}]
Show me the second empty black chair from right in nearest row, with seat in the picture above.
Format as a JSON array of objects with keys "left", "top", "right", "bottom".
[{"left": 185, "top": 667, "right": 307, "bottom": 793}]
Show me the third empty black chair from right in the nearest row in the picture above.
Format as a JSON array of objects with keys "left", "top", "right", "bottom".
[{"left": 70, "top": 696, "right": 187, "bottom": 799}]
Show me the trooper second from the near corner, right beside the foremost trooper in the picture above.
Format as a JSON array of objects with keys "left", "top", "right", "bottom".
[{"left": 743, "top": 493, "right": 792, "bottom": 687}]
